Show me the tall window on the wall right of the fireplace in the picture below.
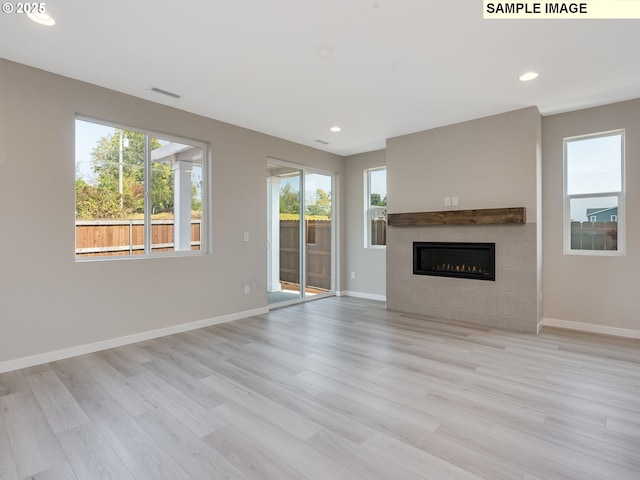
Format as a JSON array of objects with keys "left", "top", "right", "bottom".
[{"left": 564, "top": 130, "right": 625, "bottom": 255}]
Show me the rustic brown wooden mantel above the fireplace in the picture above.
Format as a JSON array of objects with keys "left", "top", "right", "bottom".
[{"left": 387, "top": 207, "right": 527, "bottom": 227}]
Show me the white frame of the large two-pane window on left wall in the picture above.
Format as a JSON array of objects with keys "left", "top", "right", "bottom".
[{"left": 74, "top": 114, "right": 212, "bottom": 263}]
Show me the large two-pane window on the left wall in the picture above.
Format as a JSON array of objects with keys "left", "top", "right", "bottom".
[{"left": 75, "top": 118, "right": 208, "bottom": 259}]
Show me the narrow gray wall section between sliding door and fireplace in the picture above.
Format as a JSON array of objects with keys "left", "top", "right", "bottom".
[{"left": 343, "top": 150, "right": 386, "bottom": 300}]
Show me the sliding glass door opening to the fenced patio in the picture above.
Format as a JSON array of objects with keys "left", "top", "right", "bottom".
[{"left": 267, "top": 161, "right": 335, "bottom": 304}]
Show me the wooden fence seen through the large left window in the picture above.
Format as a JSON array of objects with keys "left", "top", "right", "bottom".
[{"left": 76, "top": 220, "right": 200, "bottom": 257}]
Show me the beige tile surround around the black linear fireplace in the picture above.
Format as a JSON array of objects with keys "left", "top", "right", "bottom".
[{"left": 387, "top": 212, "right": 538, "bottom": 333}]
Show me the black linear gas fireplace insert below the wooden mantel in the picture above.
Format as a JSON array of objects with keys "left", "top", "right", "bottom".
[{"left": 413, "top": 242, "right": 496, "bottom": 281}]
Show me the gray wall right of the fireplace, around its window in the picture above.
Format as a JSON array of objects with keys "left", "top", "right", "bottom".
[{"left": 542, "top": 100, "right": 640, "bottom": 331}]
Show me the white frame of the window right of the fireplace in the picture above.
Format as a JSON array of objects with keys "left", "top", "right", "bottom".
[{"left": 562, "top": 128, "right": 626, "bottom": 257}]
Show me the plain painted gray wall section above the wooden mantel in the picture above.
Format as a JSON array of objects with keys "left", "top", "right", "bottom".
[{"left": 387, "top": 107, "right": 540, "bottom": 218}]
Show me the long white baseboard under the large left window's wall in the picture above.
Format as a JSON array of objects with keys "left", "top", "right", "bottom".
[{"left": 0, "top": 307, "right": 269, "bottom": 373}]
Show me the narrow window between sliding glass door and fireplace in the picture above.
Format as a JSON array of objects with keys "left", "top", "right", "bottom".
[{"left": 365, "top": 167, "right": 387, "bottom": 247}]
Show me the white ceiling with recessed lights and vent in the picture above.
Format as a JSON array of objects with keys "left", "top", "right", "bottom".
[{"left": 0, "top": 0, "right": 640, "bottom": 155}]
